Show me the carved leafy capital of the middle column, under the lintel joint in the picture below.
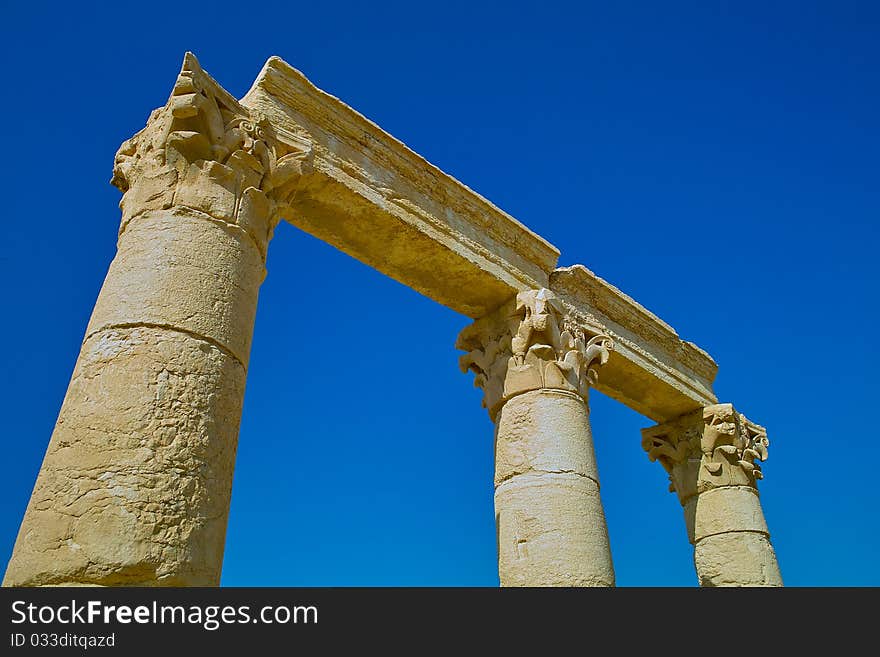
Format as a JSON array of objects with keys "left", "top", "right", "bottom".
[{"left": 456, "top": 288, "right": 613, "bottom": 419}]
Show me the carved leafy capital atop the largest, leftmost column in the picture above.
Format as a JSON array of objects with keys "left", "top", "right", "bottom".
[{"left": 111, "top": 53, "right": 311, "bottom": 259}]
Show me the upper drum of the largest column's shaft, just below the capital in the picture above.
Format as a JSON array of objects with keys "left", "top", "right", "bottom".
[{"left": 86, "top": 210, "right": 265, "bottom": 365}]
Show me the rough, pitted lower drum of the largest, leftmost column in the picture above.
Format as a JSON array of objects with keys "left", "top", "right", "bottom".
[{"left": 5, "top": 326, "right": 245, "bottom": 586}]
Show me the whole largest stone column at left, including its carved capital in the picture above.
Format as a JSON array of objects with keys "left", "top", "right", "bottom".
[{"left": 4, "top": 54, "right": 308, "bottom": 586}]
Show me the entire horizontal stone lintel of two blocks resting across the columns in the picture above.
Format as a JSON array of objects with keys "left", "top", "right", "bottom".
[{"left": 199, "top": 57, "right": 717, "bottom": 422}]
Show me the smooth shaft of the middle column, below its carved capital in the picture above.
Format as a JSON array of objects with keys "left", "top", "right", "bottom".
[{"left": 495, "top": 390, "right": 614, "bottom": 586}]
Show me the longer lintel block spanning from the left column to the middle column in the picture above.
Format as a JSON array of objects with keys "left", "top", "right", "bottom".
[{"left": 241, "top": 57, "right": 559, "bottom": 318}]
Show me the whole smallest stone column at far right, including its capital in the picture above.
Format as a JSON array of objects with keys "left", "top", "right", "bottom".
[{"left": 642, "top": 404, "right": 782, "bottom": 586}]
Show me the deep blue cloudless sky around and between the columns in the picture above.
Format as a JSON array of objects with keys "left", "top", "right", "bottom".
[{"left": 0, "top": 1, "right": 880, "bottom": 586}]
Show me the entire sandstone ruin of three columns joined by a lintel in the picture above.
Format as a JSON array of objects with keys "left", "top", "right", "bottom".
[{"left": 3, "top": 53, "right": 782, "bottom": 586}]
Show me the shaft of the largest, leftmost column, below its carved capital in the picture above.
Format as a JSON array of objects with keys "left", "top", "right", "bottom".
[{"left": 4, "top": 206, "right": 264, "bottom": 586}]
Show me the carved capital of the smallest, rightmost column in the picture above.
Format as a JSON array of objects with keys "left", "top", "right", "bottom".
[{"left": 642, "top": 404, "right": 770, "bottom": 504}]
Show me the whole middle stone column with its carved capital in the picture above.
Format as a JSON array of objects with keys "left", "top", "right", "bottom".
[{"left": 457, "top": 289, "right": 614, "bottom": 586}]
